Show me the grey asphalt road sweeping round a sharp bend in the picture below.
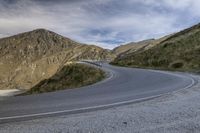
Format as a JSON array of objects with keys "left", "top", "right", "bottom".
[{"left": 0, "top": 64, "right": 195, "bottom": 123}]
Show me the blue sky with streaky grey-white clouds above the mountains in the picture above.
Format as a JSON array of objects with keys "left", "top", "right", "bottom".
[{"left": 0, "top": 0, "right": 200, "bottom": 49}]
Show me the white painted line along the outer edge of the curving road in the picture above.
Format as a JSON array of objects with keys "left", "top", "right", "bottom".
[{"left": 0, "top": 70, "right": 195, "bottom": 120}]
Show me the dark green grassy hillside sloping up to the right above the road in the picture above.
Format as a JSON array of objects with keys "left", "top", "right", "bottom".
[{"left": 112, "top": 24, "right": 200, "bottom": 72}]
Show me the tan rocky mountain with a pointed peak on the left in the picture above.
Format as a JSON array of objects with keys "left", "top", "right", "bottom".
[{"left": 0, "top": 29, "right": 113, "bottom": 89}]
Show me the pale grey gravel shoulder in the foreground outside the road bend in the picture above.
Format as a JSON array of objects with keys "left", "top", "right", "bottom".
[{"left": 0, "top": 75, "right": 200, "bottom": 133}]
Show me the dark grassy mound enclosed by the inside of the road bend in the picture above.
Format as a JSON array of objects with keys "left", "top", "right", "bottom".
[{"left": 22, "top": 63, "right": 105, "bottom": 95}]
